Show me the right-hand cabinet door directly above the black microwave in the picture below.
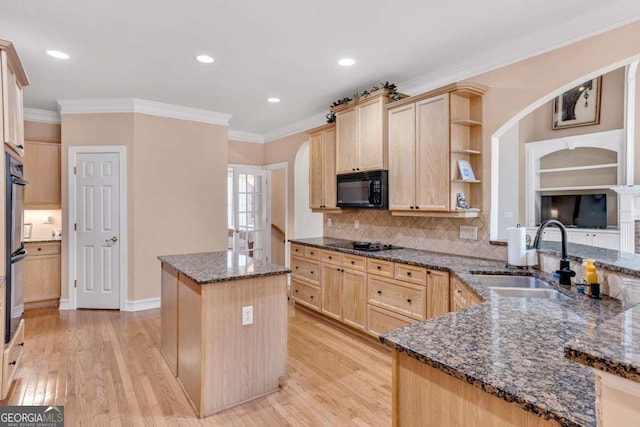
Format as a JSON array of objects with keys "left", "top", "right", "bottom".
[{"left": 357, "top": 98, "right": 387, "bottom": 171}]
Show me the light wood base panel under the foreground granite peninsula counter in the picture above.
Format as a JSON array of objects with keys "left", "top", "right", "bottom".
[{"left": 391, "top": 350, "right": 559, "bottom": 427}]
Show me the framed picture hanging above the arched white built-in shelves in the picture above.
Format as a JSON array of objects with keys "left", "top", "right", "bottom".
[{"left": 552, "top": 76, "right": 602, "bottom": 130}]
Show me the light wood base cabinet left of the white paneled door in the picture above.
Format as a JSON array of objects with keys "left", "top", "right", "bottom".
[{"left": 24, "top": 242, "right": 62, "bottom": 309}]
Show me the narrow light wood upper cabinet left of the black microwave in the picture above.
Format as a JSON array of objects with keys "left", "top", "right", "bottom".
[{"left": 307, "top": 124, "right": 338, "bottom": 210}]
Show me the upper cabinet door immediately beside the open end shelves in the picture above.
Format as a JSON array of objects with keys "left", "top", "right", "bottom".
[{"left": 416, "top": 94, "right": 451, "bottom": 211}]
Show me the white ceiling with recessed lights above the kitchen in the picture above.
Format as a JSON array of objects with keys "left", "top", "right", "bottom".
[{"left": 0, "top": 0, "right": 640, "bottom": 140}]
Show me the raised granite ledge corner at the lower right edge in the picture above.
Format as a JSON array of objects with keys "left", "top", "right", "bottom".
[{"left": 564, "top": 306, "right": 640, "bottom": 382}]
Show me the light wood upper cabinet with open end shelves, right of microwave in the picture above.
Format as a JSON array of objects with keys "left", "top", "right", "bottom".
[{"left": 388, "top": 83, "right": 486, "bottom": 217}]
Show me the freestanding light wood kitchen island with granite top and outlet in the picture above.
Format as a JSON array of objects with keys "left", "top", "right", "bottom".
[{"left": 158, "top": 251, "right": 290, "bottom": 418}]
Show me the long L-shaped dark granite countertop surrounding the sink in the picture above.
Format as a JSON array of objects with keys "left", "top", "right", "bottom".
[{"left": 292, "top": 238, "right": 640, "bottom": 426}]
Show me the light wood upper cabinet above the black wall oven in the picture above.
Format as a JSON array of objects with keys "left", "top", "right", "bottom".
[{"left": 0, "top": 40, "right": 29, "bottom": 155}]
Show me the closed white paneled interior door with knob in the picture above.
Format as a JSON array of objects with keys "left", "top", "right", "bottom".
[{"left": 75, "top": 152, "right": 122, "bottom": 309}]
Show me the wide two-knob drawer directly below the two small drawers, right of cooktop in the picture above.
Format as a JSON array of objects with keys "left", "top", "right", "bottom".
[{"left": 367, "top": 276, "right": 427, "bottom": 320}]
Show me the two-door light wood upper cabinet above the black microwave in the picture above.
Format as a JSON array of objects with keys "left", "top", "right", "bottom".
[{"left": 331, "top": 89, "right": 390, "bottom": 174}]
